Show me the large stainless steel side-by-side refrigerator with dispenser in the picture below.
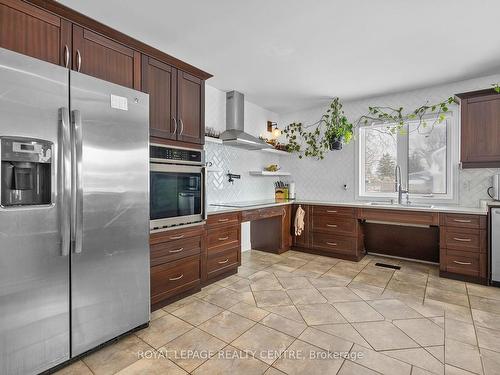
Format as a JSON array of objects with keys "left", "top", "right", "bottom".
[{"left": 0, "top": 49, "right": 150, "bottom": 375}]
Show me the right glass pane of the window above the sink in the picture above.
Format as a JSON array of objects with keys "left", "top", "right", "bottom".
[{"left": 408, "top": 120, "right": 447, "bottom": 194}]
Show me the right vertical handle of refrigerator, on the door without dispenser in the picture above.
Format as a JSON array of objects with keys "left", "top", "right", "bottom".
[{"left": 72, "top": 110, "right": 83, "bottom": 254}]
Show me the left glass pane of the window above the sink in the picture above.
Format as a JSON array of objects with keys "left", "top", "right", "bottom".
[{"left": 361, "top": 127, "right": 397, "bottom": 193}]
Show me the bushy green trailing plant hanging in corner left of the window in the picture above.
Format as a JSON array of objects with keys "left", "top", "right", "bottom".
[{"left": 283, "top": 97, "right": 354, "bottom": 159}]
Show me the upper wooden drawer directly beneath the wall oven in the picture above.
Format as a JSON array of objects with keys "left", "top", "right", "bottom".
[{"left": 150, "top": 236, "right": 202, "bottom": 266}]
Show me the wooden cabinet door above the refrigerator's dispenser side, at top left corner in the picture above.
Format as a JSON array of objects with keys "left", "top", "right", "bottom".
[{"left": 0, "top": 0, "right": 71, "bottom": 65}]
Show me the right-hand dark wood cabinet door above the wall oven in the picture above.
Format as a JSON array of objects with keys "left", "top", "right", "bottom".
[{"left": 177, "top": 70, "right": 205, "bottom": 144}]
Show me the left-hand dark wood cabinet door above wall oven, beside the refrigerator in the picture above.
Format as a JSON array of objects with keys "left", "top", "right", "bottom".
[{"left": 142, "top": 55, "right": 178, "bottom": 139}]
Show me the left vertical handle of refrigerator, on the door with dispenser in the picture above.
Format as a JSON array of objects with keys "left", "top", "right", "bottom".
[{"left": 58, "top": 108, "right": 71, "bottom": 256}]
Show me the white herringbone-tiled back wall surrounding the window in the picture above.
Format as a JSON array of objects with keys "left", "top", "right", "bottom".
[{"left": 280, "top": 74, "right": 500, "bottom": 207}]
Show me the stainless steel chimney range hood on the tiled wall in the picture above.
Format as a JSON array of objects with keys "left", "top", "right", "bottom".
[{"left": 220, "top": 91, "right": 273, "bottom": 150}]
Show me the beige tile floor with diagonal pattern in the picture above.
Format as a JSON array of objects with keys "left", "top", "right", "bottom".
[{"left": 55, "top": 250, "right": 500, "bottom": 375}]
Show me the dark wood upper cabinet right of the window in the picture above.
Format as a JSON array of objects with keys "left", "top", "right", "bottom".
[{"left": 457, "top": 90, "right": 500, "bottom": 168}]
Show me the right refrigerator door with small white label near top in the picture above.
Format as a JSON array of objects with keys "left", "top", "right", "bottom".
[{"left": 70, "top": 71, "right": 150, "bottom": 356}]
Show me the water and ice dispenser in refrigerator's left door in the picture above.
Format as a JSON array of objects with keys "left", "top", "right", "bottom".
[{"left": 0, "top": 137, "right": 53, "bottom": 207}]
